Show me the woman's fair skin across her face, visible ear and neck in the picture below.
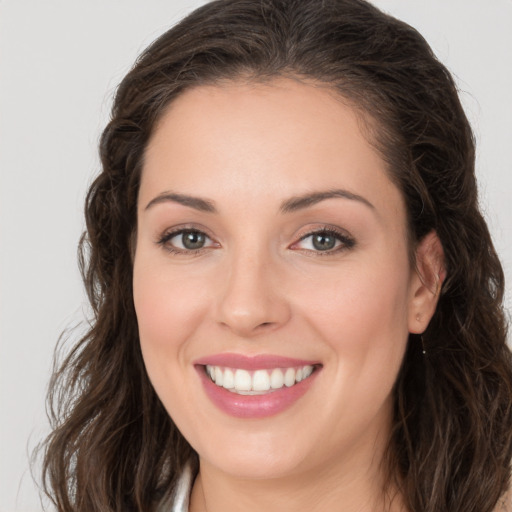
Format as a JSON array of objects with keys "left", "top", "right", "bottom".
[{"left": 133, "top": 79, "right": 443, "bottom": 512}]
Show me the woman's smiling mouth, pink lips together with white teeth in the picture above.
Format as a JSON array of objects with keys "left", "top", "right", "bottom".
[{"left": 195, "top": 354, "right": 321, "bottom": 418}]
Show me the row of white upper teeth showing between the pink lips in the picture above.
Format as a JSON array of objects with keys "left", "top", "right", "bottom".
[{"left": 206, "top": 364, "right": 313, "bottom": 394}]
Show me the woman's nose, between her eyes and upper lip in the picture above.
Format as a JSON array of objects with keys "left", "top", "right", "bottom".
[{"left": 216, "top": 247, "right": 291, "bottom": 338}]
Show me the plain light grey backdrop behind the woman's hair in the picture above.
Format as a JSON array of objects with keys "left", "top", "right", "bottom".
[{"left": 0, "top": 0, "right": 512, "bottom": 512}]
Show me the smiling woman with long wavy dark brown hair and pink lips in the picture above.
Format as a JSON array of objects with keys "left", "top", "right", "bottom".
[{"left": 45, "top": 0, "right": 512, "bottom": 512}]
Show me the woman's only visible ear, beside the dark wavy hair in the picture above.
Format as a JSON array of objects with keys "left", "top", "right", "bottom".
[{"left": 408, "top": 231, "right": 446, "bottom": 334}]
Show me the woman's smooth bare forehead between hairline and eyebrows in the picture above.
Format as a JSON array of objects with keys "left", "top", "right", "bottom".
[{"left": 140, "top": 79, "right": 402, "bottom": 220}]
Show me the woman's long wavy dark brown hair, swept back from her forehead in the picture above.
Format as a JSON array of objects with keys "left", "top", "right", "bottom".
[{"left": 43, "top": 0, "right": 512, "bottom": 512}]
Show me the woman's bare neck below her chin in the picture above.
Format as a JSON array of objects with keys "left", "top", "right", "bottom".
[{"left": 190, "top": 436, "right": 406, "bottom": 512}]
